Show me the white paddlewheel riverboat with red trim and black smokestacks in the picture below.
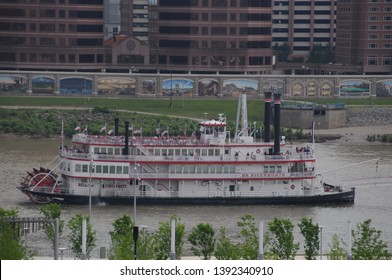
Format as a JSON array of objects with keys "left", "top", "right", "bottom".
[{"left": 18, "top": 92, "right": 355, "bottom": 205}]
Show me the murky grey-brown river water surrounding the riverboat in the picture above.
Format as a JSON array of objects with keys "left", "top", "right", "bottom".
[{"left": 0, "top": 135, "right": 392, "bottom": 255}]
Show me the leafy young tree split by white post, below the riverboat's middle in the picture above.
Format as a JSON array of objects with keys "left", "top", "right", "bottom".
[{"left": 154, "top": 215, "right": 185, "bottom": 260}]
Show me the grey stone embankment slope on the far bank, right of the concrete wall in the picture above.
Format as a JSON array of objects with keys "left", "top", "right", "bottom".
[{"left": 346, "top": 106, "right": 392, "bottom": 127}]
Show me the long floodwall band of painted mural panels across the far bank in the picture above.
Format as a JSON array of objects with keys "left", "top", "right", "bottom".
[{"left": 0, "top": 73, "right": 392, "bottom": 98}]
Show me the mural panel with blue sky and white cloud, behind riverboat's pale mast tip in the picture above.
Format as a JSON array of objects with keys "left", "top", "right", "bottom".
[{"left": 223, "top": 79, "right": 259, "bottom": 98}]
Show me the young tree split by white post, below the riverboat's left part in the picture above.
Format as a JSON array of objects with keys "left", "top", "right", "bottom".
[{"left": 68, "top": 214, "right": 97, "bottom": 259}]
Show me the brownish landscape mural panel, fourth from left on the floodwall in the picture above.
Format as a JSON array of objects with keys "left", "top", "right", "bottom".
[{"left": 97, "top": 78, "right": 136, "bottom": 95}]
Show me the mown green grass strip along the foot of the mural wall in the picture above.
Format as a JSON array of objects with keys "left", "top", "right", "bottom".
[{"left": 0, "top": 96, "right": 392, "bottom": 122}]
